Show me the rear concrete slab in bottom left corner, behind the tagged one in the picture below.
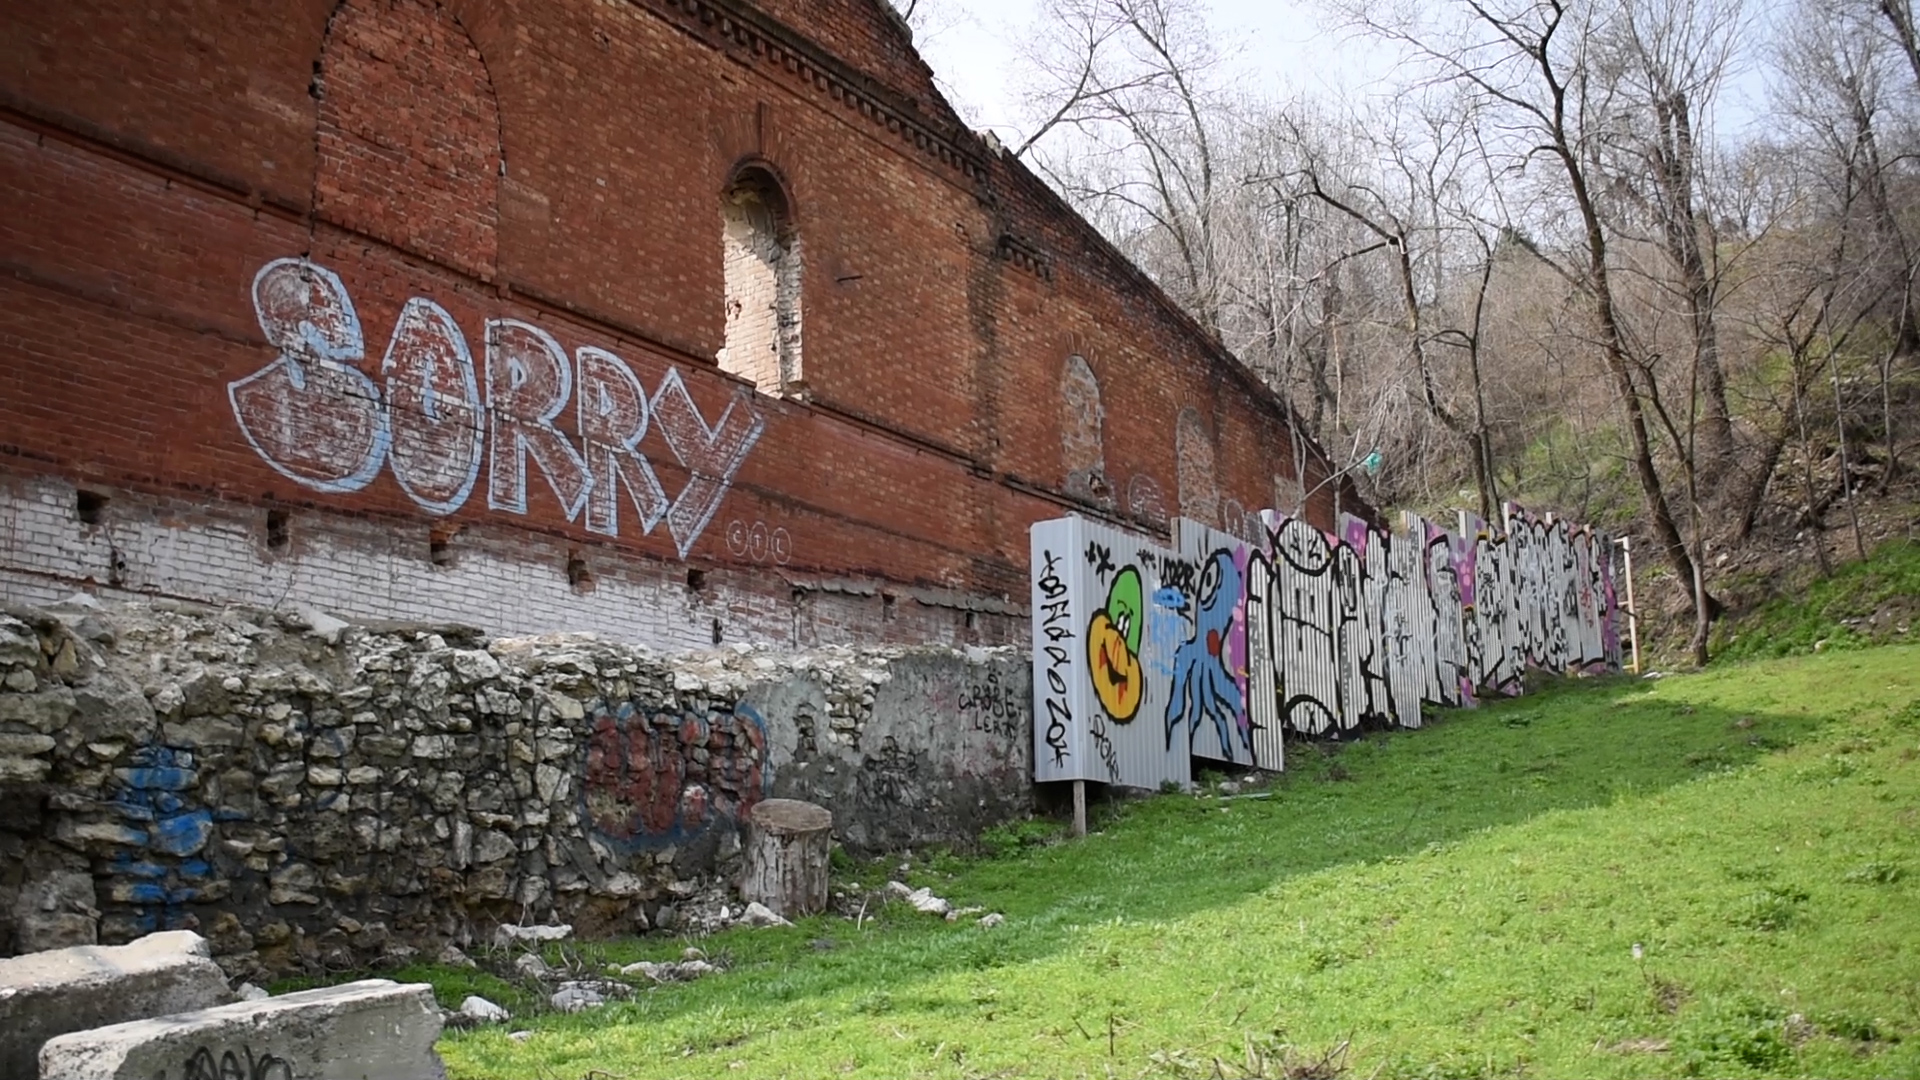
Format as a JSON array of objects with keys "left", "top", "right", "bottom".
[{"left": 0, "top": 930, "right": 232, "bottom": 1080}]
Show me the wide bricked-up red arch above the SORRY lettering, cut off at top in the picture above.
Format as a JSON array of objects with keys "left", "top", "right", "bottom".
[{"left": 313, "top": 0, "right": 503, "bottom": 279}]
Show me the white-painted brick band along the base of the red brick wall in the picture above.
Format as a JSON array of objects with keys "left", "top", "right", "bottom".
[{"left": 0, "top": 477, "right": 1023, "bottom": 650}]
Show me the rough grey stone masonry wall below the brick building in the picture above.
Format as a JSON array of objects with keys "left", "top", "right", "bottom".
[{"left": 0, "top": 596, "right": 1031, "bottom": 978}]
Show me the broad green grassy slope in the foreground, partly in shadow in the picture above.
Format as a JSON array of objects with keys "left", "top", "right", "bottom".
[{"left": 415, "top": 648, "right": 1920, "bottom": 1080}]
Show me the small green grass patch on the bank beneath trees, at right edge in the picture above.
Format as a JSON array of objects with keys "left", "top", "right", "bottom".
[{"left": 1713, "top": 540, "right": 1920, "bottom": 659}]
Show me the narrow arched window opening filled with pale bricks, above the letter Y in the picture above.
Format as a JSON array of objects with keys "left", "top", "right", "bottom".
[{"left": 720, "top": 167, "right": 801, "bottom": 394}]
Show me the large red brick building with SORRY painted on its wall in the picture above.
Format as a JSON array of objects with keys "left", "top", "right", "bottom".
[{"left": 0, "top": 0, "right": 1331, "bottom": 646}]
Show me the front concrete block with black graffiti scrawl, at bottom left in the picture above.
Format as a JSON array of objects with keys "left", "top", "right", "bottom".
[{"left": 40, "top": 978, "right": 447, "bottom": 1080}]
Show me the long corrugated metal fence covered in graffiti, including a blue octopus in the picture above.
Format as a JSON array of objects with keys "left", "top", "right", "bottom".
[{"left": 1033, "top": 505, "right": 1620, "bottom": 788}]
